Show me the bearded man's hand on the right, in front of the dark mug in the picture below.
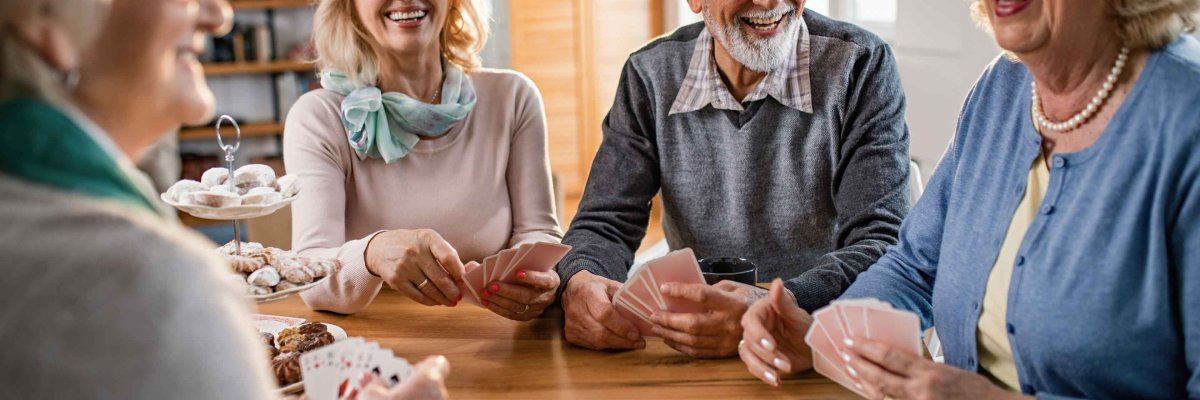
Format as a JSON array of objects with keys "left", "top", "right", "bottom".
[{"left": 650, "top": 281, "right": 767, "bottom": 358}]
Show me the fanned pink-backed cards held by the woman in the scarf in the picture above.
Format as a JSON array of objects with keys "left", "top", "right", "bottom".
[{"left": 458, "top": 241, "right": 571, "bottom": 306}]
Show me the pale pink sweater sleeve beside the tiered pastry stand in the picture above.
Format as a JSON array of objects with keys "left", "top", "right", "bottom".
[{"left": 283, "top": 91, "right": 383, "bottom": 314}]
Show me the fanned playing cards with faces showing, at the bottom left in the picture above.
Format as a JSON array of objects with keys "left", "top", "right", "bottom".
[{"left": 300, "top": 338, "right": 413, "bottom": 400}]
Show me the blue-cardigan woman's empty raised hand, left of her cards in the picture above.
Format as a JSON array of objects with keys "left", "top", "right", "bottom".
[{"left": 738, "top": 279, "right": 812, "bottom": 386}]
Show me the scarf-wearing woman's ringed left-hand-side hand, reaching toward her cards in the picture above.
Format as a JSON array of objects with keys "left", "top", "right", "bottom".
[{"left": 365, "top": 229, "right": 463, "bottom": 306}]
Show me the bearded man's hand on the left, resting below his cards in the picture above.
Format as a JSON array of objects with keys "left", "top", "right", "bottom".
[{"left": 563, "top": 270, "right": 646, "bottom": 350}]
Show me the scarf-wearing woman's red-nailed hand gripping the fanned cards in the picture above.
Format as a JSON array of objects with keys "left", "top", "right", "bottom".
[{"left": 480, "top": 269, "right": 559, "bottom": 321}]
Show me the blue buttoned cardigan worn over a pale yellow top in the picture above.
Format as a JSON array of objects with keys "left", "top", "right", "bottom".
[{"left": 842, "top": 36, "right": 1200, "bottom": 399}]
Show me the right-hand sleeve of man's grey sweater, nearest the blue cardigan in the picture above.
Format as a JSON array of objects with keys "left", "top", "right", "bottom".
[{"left": 785, "top": 43, "right": 910, "bottom": 311}]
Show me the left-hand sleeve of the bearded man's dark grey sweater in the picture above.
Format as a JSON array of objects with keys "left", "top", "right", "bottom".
[{"left": 558, "top": 61, "right": 660, "bottom": 291}]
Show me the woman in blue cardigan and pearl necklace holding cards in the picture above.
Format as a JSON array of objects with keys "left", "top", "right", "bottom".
[{"left": 742, "top": 0, "right": 1200, "bottom": 399}]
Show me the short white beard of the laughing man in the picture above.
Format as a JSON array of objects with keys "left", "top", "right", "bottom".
[{"left": 703, "top": 1, "right": 800, "bottom": 72}]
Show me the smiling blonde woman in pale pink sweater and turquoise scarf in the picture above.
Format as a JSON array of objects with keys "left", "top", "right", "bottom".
[{"left": 283, "top": 0, "right": 562, "bottom": 320}]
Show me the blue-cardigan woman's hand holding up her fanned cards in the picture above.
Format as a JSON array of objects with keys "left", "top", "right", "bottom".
[{"left": 844, "top": 338, "right": 1026, "bottom": 400}]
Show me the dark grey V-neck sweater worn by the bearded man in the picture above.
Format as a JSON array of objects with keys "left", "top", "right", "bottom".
[{"left": 558, "top": 12, "right": 910, "bottom": 311}]
